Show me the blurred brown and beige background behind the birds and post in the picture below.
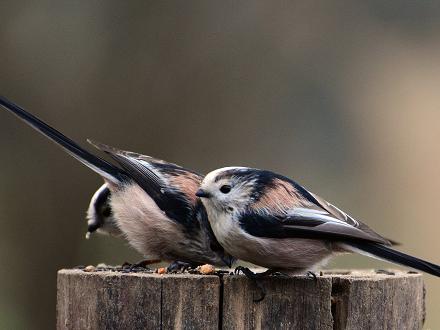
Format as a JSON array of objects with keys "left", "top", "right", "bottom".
[{"left": 0, "top": 0, "right": 440, "bottom": 329}]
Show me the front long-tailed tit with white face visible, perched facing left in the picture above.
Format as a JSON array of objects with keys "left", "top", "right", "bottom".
[{"left": 196, "top": 167, "right": 440, "bottom": 276}]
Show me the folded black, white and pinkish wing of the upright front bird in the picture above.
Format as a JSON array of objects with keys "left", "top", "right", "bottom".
[{"left": 244, "top": 174, "right": 390, "bottom": 245}]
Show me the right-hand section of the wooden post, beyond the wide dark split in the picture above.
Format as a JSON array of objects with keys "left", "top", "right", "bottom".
[{"left": 332, "top": 271, "right": 425, "bottom": 329}]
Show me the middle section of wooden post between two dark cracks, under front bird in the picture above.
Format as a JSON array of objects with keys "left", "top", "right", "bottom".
[{"left": 222, "top": 276, "right": 333, "bottom": 329}]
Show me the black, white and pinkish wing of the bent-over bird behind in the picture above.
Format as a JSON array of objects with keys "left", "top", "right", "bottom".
[{"left": 88, "top": 140, "right": 235, "bottom": 267}]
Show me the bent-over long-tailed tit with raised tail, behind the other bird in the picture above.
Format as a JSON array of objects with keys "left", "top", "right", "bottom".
[{"left": 0, "top": 97, "right": 233, "bottom": 266}]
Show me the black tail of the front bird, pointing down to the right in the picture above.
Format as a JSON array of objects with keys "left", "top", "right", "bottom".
[{"left": 348, "top": 242, "right": 440, "bottom": 277}]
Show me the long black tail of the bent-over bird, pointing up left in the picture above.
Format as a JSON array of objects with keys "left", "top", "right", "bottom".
[{"left": 0, "top": 96, "right": 126, "bottom": 183}]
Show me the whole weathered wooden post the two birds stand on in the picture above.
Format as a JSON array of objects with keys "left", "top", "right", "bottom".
[{"left": 57, "top": 270, "right": 425, "bottom": 329}]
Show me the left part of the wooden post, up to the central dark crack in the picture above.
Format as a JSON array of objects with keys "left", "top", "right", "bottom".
[{"left": 57, "top": 270, "right": 220, "bottom": 329}]
